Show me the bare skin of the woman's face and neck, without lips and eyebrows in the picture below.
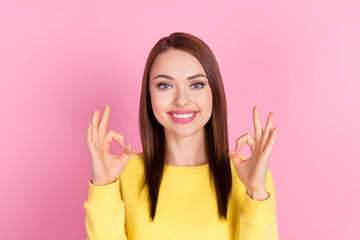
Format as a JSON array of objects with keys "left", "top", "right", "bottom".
[{"left": 149, "top": 49, "right": 213, "bottom": 166}]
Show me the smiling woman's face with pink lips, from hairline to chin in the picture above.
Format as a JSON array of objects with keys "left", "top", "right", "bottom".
[{"left": 149, "top": 49, "right": 212, "bottom": 137}]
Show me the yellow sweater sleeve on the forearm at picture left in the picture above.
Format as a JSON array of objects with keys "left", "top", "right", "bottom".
[{"left": 84, "top": 179, "right": 128, "bottom": 240}]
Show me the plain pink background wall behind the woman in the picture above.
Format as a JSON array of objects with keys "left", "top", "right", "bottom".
[{"left": 0, "top": 0, "right": 360, "bottom": 240}]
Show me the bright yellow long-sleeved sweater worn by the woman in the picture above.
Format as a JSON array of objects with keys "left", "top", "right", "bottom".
[{"left": 84, "top": 153, "right": 279, "bottom": 240}]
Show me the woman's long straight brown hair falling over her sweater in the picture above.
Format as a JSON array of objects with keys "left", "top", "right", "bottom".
[{"left": 139, "top": 32, "right": 232, "bottom": 221}]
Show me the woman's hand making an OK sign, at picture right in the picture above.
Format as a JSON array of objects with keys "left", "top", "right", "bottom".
[{"left": 228, "top": 107, "right": 278, "bottom": 200}]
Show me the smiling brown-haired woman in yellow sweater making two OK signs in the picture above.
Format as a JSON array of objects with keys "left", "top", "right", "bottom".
[{"left": 84, "top": 32, "right": 278, "bottom": 240}]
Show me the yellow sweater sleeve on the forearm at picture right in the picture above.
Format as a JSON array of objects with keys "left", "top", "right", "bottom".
[{"left": 239, "top": 169, "right": 279, "bottom": 240}]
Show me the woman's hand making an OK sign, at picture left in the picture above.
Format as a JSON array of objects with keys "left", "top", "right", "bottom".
[{"left": 86, "top": 104, "right": 134, "bottom": 186}]
